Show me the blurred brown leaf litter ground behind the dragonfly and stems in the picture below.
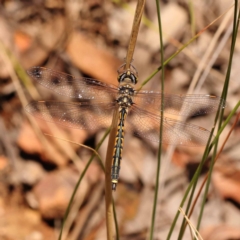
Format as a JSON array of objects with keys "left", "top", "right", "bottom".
[{"left": 0, "top": 0, "right": 240, "bottom": 240}]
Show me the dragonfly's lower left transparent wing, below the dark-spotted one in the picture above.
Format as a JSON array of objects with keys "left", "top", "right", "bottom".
[{"left": 25, "top": 101, "right": 115, "bottom": 130}]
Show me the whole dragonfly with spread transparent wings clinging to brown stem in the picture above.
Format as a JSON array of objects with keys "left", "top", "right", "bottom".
[{"left": 25, "top": 64, "right": 224, "bottom": 190}]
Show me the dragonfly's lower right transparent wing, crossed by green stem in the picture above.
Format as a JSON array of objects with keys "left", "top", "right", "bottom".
[{"left": 128, "top": 106, "right": 210, "bottom": 147}]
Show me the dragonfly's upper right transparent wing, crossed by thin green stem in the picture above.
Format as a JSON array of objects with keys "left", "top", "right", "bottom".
[{"left": 134, "top": 90, "right": 224, "bottom": 116}]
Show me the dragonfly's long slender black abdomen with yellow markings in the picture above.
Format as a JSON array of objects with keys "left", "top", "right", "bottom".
[{"left": 111, "top": 107, "right": 128, "bottom": 190}]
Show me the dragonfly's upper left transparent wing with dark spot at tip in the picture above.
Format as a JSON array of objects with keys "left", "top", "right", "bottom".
[{"left": 27, "top": 67, "right": 118, "bottom": 101}]
